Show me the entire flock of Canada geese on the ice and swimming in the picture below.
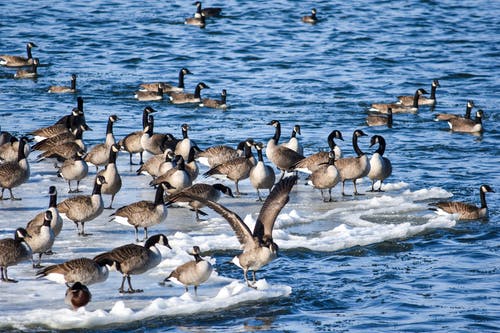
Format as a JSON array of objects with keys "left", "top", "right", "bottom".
[{"left": 0, "top": 2, "right": 493, "bottom": 309}]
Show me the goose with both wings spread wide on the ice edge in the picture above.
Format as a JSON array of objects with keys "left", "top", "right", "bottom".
[{"left": 168, "top": 176, "right": 297, "bottom": 288}]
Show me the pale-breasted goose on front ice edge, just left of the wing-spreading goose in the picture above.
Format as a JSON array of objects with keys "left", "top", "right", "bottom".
[{"left": 163, "top": 246, "right": 213, "bottom": 295}]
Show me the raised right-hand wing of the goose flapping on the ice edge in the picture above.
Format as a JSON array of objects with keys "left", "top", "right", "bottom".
[{"left": 253, "top": 176, "right": 298, "bottom": 239}]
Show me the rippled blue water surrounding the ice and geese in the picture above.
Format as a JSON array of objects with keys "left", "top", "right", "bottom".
[{"left": 0, "top": 0, "right": 500, "bottom": 332}]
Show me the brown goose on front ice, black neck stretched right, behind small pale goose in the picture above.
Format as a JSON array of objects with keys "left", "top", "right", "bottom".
[{"left": 94, "top": 234, "right": 171, "bottom": 293}]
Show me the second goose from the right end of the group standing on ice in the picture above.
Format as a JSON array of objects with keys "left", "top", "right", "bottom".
[{"left": 335, "top": 130, "right": 370, "bottom": 195}]
